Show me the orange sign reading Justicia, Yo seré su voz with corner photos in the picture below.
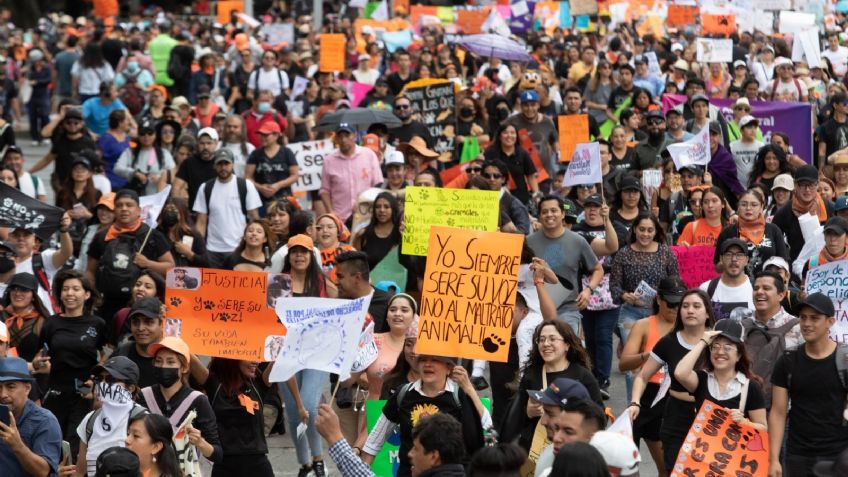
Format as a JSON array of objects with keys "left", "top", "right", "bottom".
[{"left": 165, "top": 267, "right": 291, "bottom": 361}]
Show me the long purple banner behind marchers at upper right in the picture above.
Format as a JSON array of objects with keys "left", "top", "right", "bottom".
[{"left": 663, "top": 94, "right": 813, "bottom": 164}]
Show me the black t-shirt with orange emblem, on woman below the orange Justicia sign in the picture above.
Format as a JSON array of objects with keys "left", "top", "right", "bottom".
[{"left": 203, "top": 374, "right": 268, "bottom": 456}]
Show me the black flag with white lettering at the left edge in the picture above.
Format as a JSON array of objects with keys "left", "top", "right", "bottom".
[{"left": 0, "top": 181, "right": 65, "bottom": 240}]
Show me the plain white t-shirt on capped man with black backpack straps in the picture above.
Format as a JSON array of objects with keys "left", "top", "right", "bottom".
[{"left": 193, "top": 176, "right": 262, "bottom": 253}]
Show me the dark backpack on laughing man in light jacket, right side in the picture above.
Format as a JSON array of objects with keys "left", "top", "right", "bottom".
[{"left": 742, "top": 318, "right": 801, "bottom": 409}]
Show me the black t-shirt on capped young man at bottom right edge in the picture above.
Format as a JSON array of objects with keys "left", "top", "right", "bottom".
[{"left": 771, "top": 346, "right": 848, "bottom": 457}]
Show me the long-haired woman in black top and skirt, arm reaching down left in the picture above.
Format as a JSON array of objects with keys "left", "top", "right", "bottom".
[{"left": 628, "top": 289, "right": 715, "bottom": 472}]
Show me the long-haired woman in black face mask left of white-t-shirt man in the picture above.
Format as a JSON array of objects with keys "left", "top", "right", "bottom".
[{"left": 156, "top": 197, "right": 209, "bottom": 267}]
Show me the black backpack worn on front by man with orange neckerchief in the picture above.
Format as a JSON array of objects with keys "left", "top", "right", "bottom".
[{"left": 96, "top": 230, "right": 147, "bottom": 295}]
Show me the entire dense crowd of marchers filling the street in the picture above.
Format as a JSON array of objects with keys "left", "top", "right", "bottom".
[{"left": 0, "top": 1, "right": 848, "bottom": 477}]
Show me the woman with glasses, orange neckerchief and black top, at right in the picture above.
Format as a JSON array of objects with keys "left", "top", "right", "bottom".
[{"left": 713, "top": 189, "right": 789, "bottom": 280}]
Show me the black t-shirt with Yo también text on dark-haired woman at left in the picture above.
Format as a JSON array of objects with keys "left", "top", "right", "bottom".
[{"left": 39, "top": 315, "right": 106, "bottom": 392}]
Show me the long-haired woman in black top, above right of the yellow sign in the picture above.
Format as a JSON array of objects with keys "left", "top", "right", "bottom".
[{"left": 483, "top": 123, "right": 539, "bottom": 204}]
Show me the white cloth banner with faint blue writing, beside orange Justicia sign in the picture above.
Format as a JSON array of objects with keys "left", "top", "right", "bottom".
[{"left": 269, "top": 294, "right": 373, "bottom": 382}]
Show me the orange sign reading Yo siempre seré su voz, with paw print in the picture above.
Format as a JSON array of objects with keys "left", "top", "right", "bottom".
[{"left": 416, "top": 227, "right": 524, "bottom": 362}]
